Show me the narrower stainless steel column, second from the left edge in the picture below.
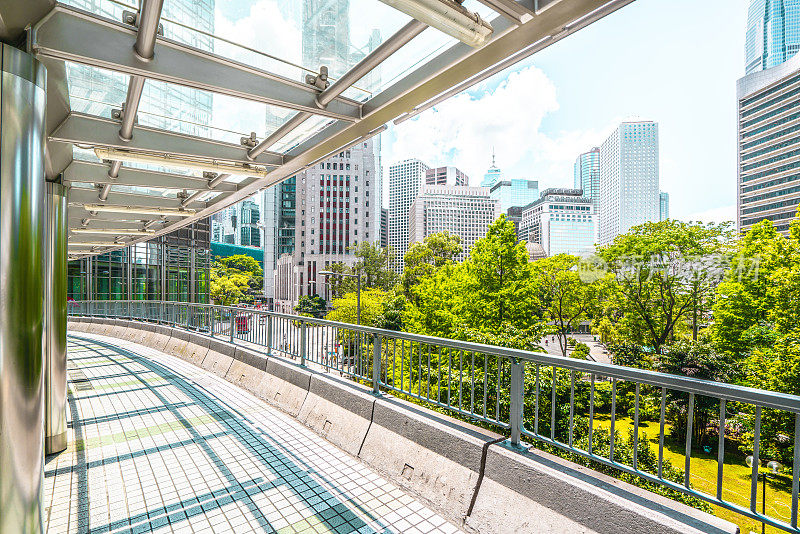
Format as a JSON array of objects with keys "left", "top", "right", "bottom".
[{"left": 44, "top": 183, "right": 67, "bottom": 454}]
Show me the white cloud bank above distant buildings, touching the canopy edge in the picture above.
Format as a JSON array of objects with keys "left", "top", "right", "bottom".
[{"left": 384, "top": 66, "right": 619, "bottom": 189}]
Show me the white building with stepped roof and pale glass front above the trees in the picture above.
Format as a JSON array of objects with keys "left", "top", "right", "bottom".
[{"left": 520, "top": 189, "right": 597, "bottom": 256}]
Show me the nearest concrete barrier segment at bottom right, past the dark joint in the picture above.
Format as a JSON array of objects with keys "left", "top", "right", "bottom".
[{"left": 466, "top": 444, "right": 738, "bottom": 534}]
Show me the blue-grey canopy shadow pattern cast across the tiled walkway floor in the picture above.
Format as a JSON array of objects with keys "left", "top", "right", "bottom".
[{"left": 70, "top": 335, "right": 391, "bottom": 532}]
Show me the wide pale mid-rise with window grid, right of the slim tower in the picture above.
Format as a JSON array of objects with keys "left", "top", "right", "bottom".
[{"left": 409, "top": 185, "right": 500, "bottom": 261}]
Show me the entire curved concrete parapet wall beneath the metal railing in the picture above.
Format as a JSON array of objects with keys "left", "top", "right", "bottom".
[{"left": 69, "top": 318, "right": 738, "bottom": 534}]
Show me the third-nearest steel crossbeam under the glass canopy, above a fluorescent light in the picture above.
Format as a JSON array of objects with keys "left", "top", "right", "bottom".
[{"left": 64, "top": 160, "right": 237, "bottom": 192}]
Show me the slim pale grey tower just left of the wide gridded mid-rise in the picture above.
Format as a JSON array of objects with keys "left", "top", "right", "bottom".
[{"left": 389, "top": 159, "right": 429, "bottom": 272}]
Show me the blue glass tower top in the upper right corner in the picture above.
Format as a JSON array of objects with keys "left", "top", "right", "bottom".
[{"left": 744, "top": 0, "right": 800, "bottom": 74}]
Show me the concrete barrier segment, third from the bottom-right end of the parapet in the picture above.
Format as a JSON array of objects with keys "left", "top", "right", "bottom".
[{"left": 297, "top": 373, "right": 377, "bottom": 456}]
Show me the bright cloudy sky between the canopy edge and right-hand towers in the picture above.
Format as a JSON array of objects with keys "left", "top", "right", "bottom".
[{"left": 383, "top": 0, "right": 748, "bottom": 220}]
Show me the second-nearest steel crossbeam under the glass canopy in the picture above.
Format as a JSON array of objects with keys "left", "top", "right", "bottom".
[{"left": 49, "top": 113, "right": 283, "bottom": 167}]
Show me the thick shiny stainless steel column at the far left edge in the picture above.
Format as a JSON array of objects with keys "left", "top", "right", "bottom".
[{"left": 0, "top": 44, "right": 46, "bottom": 534}]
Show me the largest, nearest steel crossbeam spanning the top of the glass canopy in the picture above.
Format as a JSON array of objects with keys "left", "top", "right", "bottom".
[{"left": 31, "top": 5, "right": 361, "bottom": 121}]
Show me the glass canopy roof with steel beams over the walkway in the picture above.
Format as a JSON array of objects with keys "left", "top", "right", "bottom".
[{"left": 30, "top": 0, "right": 633, "bottom": 260}]
